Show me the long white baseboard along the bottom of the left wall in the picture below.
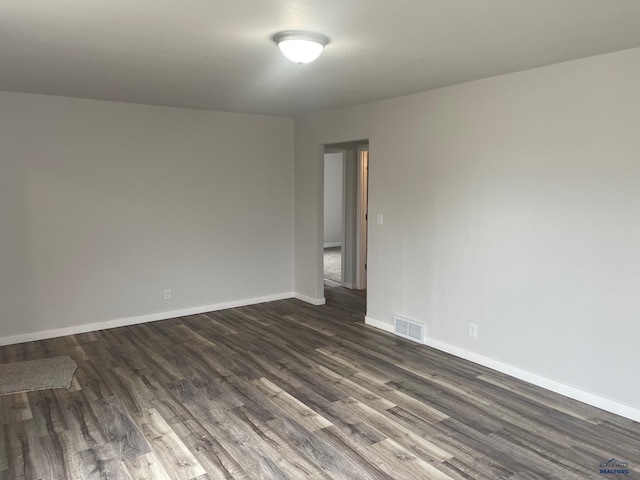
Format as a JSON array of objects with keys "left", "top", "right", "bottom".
[{"left": 0, "top": 293, "right": 294, "bottom": 346}]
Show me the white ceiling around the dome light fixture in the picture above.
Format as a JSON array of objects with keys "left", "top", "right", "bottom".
[{"left": 0, "top": 0, "right": 640, "bottom": 116}]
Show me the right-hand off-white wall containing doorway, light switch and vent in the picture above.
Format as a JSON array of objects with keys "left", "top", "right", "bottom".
[{"left": 295, "top": 49, "right": 640, "bottom": 415}]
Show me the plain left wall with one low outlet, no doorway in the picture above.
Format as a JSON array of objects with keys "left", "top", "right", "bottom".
[{"left": 0, "top": 93, "right": 294, "bottom": 339}]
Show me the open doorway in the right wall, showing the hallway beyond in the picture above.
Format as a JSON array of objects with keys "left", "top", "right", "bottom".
[{"left": 322, "top": 141, "right": 369, "bottom": 293}]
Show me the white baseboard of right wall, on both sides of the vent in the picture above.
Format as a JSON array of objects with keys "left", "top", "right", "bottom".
[{"left": 365, "top": 317, "right": 640, "bottom": 422}]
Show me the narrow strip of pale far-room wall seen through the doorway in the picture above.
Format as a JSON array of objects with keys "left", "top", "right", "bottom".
[{"left": 324, "top": 153, "right": 344, "bottom": 247}]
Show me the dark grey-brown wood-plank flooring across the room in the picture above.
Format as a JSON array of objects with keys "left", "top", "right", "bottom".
[{"left": 0, "top": 288, "right": 640, "bottom": 480}]
